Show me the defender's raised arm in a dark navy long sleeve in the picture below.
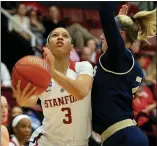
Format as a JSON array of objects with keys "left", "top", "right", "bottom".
[{"left": 99, "top": 2, "right": 125, "bottom": 58}]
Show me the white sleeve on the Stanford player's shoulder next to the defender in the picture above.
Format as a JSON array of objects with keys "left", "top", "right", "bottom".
[{"left": 75, "top": 61, "right": 93, "bottom": 77}]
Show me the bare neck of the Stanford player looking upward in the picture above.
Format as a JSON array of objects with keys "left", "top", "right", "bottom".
[{"left": 55, "top": 57, "right": 69, "bottom": 74}]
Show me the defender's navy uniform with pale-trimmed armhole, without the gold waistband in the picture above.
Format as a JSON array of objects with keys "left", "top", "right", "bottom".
[{"left": 92, "top": 2, "right": 148, "bottom": 146}]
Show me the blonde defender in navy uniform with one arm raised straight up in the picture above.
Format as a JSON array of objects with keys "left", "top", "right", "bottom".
[{"left": 91, "top": 2, "right": 156, "bottom": 146}]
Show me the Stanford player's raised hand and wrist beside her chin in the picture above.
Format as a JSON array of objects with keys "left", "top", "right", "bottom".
[{"left": 43, "top": 47, "right": 55, "bottom": 77}]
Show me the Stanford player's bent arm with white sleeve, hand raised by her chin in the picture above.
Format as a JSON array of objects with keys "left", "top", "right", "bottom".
[{"left": 44, "top": 48, "right": 93, "bottom": 100}]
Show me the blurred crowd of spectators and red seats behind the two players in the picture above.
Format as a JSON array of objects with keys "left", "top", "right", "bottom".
[{"left": 1, "top": 2, "right": 157, "bottom": 146}]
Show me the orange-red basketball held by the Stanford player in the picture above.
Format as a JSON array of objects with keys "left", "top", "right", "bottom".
[{"left": 12, "top": 56, "right": 51, "bottom": 94}]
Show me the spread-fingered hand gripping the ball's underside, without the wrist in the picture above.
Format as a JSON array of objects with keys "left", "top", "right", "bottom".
[{"left": 12, "top": 81, "right": 36, "bottom": 106}]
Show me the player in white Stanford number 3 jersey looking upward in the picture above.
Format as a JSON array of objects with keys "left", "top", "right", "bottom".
[{"left": 13, "top": 28, "right": 93, "bottom": 146}]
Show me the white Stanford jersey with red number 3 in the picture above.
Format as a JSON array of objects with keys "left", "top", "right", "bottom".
[{"left": 40, "top": 61, "right": 93, "bottom": 145}]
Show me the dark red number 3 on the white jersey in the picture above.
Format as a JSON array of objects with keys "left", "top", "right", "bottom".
[{"left": 61, "top": 107, "right": 72, "bottom": 124}]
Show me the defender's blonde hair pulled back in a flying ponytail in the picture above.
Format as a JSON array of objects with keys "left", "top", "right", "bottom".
[{"left": 116, "top": 9, "right": 156, "bottom": 43}]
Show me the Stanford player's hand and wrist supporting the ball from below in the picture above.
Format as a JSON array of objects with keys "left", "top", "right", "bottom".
[{"left": 12, "top": 81, "right": 38, "bottom": 107}]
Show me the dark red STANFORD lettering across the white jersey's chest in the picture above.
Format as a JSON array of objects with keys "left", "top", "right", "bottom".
[{"left": 45, "top": 95, "right": 78, "bottom": 108}]
